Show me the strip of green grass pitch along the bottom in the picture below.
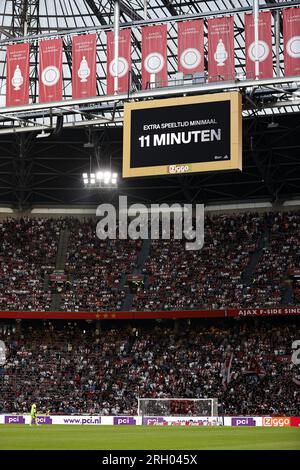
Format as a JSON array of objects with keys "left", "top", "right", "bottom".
[{"left": 0, "top": 424, "right": 300, "bottom": 450}]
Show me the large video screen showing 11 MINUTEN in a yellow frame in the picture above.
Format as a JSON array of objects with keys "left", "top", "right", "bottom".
[{"left": 123, "top": 92, "right": 242, "bottom": 178}]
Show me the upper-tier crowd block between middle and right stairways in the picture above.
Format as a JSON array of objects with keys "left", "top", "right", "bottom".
[{"left": 133, "top": 213, "right": 267, "bottom": 310}]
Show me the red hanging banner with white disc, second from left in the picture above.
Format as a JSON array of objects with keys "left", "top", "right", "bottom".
[{"left": 39, "top": 39, "right": 62, "bottom": 103}]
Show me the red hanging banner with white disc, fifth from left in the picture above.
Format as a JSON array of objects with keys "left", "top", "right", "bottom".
[{"left": 142, "top": 25, "right": 168, "bottom": 89}]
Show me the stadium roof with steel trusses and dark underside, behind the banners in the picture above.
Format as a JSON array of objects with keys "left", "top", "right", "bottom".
[{"left": 0, "top": 0, "right": 300, "bottom": 208}]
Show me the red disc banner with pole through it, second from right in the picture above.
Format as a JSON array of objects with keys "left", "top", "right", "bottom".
[{"left": 245, "top": 11, "right": 273, "bottom": 79}]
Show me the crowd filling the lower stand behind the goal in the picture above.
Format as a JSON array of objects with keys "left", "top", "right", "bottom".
[{"left": 0, "top": 317, "right": 300, "bottom": 416}]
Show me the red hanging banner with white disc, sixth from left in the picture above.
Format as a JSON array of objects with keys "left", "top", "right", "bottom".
[{"left": 178, "top": 20, "right": 204, "bottom": 74}]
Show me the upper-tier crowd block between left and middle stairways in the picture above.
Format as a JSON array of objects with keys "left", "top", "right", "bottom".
[{"left": 61, "top": 219, "right": 140, "bottom": 311}]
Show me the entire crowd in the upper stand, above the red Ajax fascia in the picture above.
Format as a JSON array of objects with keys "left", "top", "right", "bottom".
[{"left": 0, "top": 212, "right": 300, "bottom": 312}]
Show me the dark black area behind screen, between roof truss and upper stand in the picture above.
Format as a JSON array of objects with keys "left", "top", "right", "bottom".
[{"left": 0, "top": 114, "right": 300, "bottom": 208}]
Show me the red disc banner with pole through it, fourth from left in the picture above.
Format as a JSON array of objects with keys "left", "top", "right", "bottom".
[{"left": 106, "top": 29, "right": 131, "bottom": 95}]
